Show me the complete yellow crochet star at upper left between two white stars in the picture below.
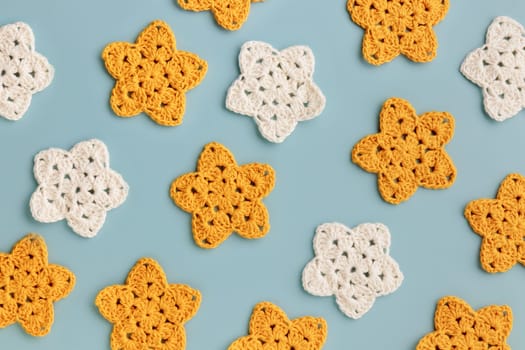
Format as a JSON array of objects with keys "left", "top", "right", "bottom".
[{"left": 102, "top": 21, "right": 208, "bottom": 126}]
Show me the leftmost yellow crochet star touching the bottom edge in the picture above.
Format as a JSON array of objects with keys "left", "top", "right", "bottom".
[{"left": 95, "top": 258, "right": 201, "bottom": 350}]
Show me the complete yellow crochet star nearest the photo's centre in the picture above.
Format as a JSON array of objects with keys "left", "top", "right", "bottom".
[{"left": 170, "top": 142, "right": 275, "bottom": 248}]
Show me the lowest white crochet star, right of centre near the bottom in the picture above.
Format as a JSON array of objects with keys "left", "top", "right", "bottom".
[{"left": 303, "top": 222, "right": 403, "bottom": 319}]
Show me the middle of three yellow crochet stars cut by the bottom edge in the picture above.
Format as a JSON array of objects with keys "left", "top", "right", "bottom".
[{"left": 228, "top": 302, "right": 327, "bottom": 350}]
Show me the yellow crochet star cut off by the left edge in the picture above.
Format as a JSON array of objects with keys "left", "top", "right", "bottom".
[{"left": 0, "top": 234, "right": 75, "bottom": 336}]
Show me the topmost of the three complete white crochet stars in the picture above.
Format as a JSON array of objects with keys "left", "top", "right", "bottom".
[{"left": 226, "top": 41, "right": 326, "bottom": 143}]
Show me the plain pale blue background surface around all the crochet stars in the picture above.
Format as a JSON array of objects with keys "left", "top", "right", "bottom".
[{"left": 0, "top": 0, "right": 525, "bottom": 350}]
